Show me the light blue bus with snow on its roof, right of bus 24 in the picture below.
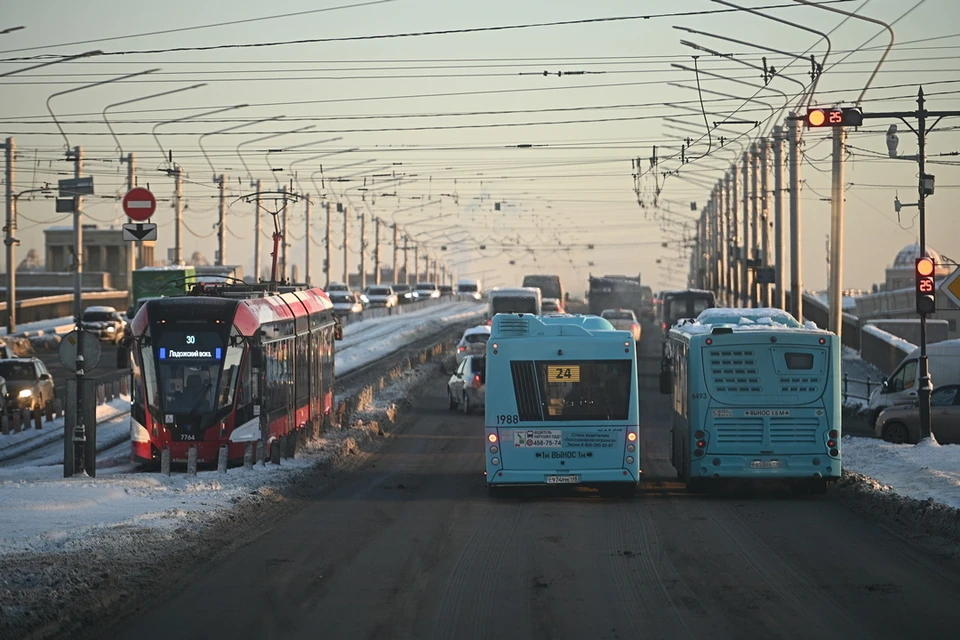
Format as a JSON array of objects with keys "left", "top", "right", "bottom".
[{"left": 660, "top": 308, "right": 841, "bottom": 493}]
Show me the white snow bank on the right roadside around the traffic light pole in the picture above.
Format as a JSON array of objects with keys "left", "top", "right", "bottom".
[{"left": 843, "top": 436, "right": 960, "bottom": 509}]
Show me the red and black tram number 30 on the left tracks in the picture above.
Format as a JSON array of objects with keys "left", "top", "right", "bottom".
[{"left": 130, "top": 283, "right": 341, "bottom": 464}]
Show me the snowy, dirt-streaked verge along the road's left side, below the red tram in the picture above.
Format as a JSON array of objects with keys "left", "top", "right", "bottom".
[{"left": 0, "top": 342, "right": 446, "bottom": 638}]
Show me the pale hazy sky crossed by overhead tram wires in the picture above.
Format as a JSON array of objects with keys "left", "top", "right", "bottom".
[{"left": 0, "top": 0, "right": 960, "bottom": 295}]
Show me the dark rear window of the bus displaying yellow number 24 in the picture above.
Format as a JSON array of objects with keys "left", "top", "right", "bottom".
[{"left": 515, "top": 360, "right": 632, "bottom": 421}]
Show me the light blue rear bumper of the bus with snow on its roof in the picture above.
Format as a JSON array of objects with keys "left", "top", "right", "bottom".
[{"left": 690, "top": 451, "right": 841, "bottom": 480}]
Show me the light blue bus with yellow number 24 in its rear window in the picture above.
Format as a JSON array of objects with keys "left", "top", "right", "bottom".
[{"left": 484, "top": 313, "right": 640, "bottom": 497}]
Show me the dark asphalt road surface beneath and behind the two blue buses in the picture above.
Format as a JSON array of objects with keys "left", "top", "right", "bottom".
[{"left": 98, "top": 328, "right": 960, "bottom": 640}]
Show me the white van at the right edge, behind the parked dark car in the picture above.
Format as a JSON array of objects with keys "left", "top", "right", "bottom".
[{"left": 867, "top": 339, "right": 960, "bottom": 423}]
